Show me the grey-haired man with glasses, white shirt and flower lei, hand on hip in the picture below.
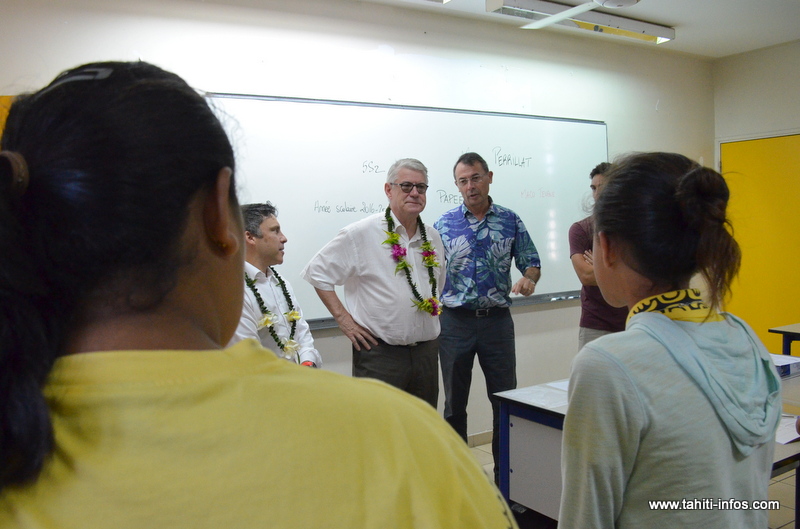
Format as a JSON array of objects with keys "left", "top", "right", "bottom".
[{"left": 301, "top": 158, "right": 444, "bottom": 408}]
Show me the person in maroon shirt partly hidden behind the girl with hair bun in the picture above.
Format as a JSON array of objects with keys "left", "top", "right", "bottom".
[{"left": 569, "top": 162, "right": 628, "bottom": 350}]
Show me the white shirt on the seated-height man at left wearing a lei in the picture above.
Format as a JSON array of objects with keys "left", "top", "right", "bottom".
[{"left": 228, "top": 261, "right": 322, "bottom": 367}]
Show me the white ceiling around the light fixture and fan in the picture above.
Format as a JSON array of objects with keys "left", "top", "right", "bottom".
[{"left": 362, "top": 0, "right": 800, "bottom": 59}]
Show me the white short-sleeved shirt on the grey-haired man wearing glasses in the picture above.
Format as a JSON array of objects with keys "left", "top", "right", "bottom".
[{"left": 300, "top": 213, "right": 445, "bottom": 345}]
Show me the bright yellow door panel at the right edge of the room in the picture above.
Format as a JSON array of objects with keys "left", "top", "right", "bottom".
[{"left": 720, "top": 135, "right": 800, "bottom": 354}]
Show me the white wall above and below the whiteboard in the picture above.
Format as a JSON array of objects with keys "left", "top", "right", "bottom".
[{"left": 0, "top": 0, "right": 714, "bottom": 433}]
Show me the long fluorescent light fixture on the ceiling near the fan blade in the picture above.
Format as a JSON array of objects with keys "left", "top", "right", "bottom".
[{"left": 486, "top": 0, "right": 675, "bottom": 44}]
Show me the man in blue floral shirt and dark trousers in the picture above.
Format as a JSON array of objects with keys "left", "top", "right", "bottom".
[{"left": 434, "top": 152, "right": 541, "bottom": 481}]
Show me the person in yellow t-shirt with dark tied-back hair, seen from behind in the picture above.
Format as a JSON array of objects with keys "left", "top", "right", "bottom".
[{"left": 0, "top": 62, "right": 516, "bottom": 529}]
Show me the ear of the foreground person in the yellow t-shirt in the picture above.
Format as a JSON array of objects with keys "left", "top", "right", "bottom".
[{"left": 203, "top": 167, "right": 242, "bottom": 257}]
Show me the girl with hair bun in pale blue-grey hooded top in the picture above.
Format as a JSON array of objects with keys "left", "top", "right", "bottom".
[{"left": 559, "top": 153, "right": 781, "bottom": 529}]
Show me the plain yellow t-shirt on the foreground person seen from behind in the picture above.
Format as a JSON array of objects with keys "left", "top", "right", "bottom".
[{"left": 0, "top": 340, "right": 516, "bottom": 529}]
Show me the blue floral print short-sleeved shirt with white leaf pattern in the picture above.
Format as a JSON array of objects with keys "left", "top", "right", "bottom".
[{"left": 433, "top": 203, "right": 541, "bottom": 309}]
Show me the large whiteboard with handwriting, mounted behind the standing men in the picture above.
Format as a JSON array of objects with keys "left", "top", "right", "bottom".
[{"left": 209, "top": 94, "right": 608, "bottom": 327}]
